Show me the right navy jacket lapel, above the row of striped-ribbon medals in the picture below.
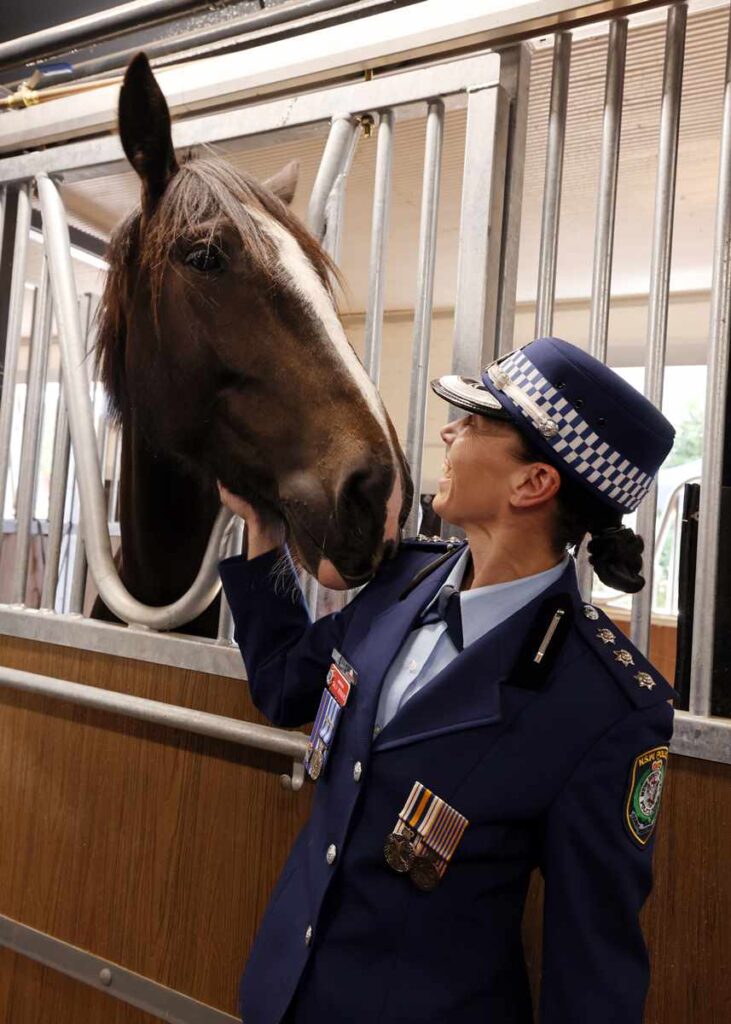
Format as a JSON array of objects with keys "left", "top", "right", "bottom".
[{"left": 372, "top": 559, "right": 581, "bottom": 751}]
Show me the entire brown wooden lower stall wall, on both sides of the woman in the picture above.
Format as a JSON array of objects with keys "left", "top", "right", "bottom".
[{"left": 0, "top": 637, "right": 731, "bottom": 1024}]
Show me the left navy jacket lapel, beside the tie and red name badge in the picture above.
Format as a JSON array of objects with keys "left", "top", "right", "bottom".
[{"left": 350, "top": 545, "right": 464, "bottom": 744}]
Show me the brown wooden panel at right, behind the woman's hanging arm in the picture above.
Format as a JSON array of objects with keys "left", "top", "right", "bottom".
[{"left": 523, "top": 755, "right": 731, "bottom": 1024}]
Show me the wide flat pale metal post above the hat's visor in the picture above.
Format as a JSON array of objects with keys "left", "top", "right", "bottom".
[{"left": 450, "top": 86, "right": 510, "bottom": 376}]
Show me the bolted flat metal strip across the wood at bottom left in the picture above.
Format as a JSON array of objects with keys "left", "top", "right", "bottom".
[{"left": 0, "top": 914, "right": 240, "bottom": 1024}]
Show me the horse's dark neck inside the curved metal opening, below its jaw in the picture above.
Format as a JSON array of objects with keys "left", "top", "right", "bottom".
[{"left": 113, "top": 420, "right": 220, "bottom": 604}]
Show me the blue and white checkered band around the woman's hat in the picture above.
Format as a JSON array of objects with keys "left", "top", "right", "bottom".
[{"left": 487, "top": 349, "right": 653, "bottom": 512}]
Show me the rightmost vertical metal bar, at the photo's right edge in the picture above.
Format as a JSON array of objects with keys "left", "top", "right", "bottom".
[{"left": 689, "top": 2, "right": 731, "bottom": 715}]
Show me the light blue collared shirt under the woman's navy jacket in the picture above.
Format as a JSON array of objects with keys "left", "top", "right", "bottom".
[{"left": 374, "top": 547, "right": 570, "bottom": 735}]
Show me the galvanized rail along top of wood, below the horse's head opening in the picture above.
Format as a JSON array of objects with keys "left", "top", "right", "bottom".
[{"left": 0, "top": 605, "right": 246, "bottom": 679}]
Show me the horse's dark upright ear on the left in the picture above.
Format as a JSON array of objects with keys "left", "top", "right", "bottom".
[{"left": 119, "top": 53, "right": 178, "bottom": 214}]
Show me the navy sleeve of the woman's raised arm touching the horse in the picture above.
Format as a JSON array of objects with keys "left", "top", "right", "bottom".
[{"left": 219, "top": 549, "right": 352, "bottom": 727}]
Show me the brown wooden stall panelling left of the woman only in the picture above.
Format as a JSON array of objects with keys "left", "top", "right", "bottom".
[{"left": 0, "top": 638, "right": 311, "bottom": 1024}]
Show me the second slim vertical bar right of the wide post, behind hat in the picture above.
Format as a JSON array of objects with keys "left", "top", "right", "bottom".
[{"left": 577, "top": 17, "right": 627, "bottom": 602}]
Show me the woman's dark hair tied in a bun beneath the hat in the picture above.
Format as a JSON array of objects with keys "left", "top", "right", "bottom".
[{"left": 512, "top": 427, "right": 645, "bottom": 594}]
